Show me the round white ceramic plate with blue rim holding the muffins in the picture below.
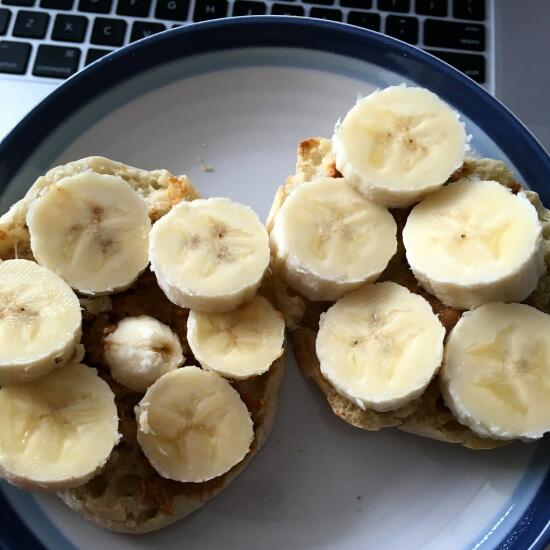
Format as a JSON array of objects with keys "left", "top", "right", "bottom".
[{"left": 0, "top": 18, "right": 550, "bottom": 550}]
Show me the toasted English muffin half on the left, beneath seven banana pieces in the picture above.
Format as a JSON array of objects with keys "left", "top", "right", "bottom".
[{"left": 0, "top": 157, "right": 283, "bottom": 534}]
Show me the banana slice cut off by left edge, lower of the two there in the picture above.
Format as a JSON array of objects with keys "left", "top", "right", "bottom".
[{"left": 0, "top": 364, "right": 120, "bottom": 491}]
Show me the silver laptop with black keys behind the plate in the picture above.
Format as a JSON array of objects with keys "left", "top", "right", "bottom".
[{"left": 0, "top": 0, "right": 550, "bottom": 150}]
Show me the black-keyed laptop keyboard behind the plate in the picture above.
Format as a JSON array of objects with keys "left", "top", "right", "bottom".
[{"left": 0, "top": 0, "right": 491, "bottom": 84}]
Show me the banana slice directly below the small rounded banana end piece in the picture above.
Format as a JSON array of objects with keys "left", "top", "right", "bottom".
[{"left": 136, "top": 367, "right": 254, "bottom": 483}]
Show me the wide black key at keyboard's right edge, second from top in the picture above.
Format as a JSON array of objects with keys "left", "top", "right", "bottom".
[{"left": 424, "top": 19, "right": 485, "bottom": 51}]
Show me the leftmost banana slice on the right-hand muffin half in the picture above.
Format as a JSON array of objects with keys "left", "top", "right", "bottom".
[{"left": 271, "top": 178, "right": 397, "bottom": 300}]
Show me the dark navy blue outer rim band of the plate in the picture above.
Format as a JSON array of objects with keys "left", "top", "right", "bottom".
[{"left": 0, "top": 16, "right": 550, "bottom": 550}]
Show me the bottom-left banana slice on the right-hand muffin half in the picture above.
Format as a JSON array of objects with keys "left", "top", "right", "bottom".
[{"left": 316, "top": 282, "right": 445, "bottom": 412}]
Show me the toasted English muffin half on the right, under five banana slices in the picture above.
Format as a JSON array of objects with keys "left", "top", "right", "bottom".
[{"left": 268, "top": 137, "right": 550, "bottom": 449}]
